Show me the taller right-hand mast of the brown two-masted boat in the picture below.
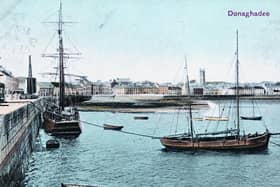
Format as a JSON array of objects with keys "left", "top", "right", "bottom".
[{"left": 236, "top": 30, "right": 240, "bottom": 137}]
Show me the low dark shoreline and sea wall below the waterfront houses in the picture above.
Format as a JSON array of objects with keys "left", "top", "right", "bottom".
[{"left": 79, "top": 95, "right": 280, "bottom": 113}]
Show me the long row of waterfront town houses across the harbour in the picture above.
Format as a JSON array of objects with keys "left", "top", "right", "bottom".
[{"left": 34, "top": 78, "right": 280, "bottom": 96}]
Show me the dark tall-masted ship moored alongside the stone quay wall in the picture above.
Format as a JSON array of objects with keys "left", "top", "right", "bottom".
[{"left": 43, "top": 2, "right": 82, "bottom": 137}]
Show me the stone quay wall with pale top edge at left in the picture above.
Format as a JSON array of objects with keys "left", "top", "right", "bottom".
[{"left": 0, "top": 99, "right": 44, "bottom": 187}]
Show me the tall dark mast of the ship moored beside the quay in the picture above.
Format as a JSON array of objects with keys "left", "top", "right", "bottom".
[{"left": 57, "top": 1, "right": 65, "bottom": 110}]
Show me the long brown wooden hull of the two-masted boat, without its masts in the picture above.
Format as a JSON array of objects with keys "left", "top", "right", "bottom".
[{"left": 160, "top": 132, "right": 270, "bottom": 151}]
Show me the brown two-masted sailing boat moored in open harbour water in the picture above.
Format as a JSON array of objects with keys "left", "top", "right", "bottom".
[{"left": 160, "top": 31, "right": 270, "bottom": 151}]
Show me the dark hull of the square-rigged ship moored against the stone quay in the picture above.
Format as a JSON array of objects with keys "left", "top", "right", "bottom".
[{"left": 44, "top": 114, "right": 82, "bottom": 138}]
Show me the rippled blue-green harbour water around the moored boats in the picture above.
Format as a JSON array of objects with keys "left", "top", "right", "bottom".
[{"left": 23, "top": 101, "right": 280, "bottom": 187}]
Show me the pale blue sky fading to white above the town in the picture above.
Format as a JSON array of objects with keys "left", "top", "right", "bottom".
[{"left": 0, "top": 0, "right": 280, "bottom": 82}]
